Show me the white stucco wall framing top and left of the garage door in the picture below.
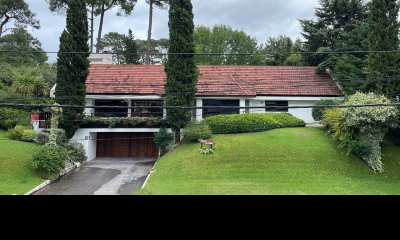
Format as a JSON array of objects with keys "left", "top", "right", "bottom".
[{"left": 71, "top": 128, "right": 159, "bottom": 161}]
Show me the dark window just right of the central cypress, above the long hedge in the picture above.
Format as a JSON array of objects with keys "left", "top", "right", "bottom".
[{"left": 203, "top": 99, "right": 240, "bottom": 118}]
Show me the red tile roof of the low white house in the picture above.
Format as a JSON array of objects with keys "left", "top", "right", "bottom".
[{"left": 86, "top": 65, "right": 343, "bottom": 96}]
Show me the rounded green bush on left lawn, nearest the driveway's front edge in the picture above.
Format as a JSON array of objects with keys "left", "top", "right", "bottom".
[{"left": 32, "top": 145, "right": 68, "bottom": 178}]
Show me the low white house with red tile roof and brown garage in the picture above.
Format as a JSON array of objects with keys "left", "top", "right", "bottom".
[{"left": 43, "top": 64, "right": 343, "bottom": 160}]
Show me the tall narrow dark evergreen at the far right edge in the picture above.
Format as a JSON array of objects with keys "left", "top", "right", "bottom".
[{"left": 368, "top": 0, "right": 400, "bottom": 97}]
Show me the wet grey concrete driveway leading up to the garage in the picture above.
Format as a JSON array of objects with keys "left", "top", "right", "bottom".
[{"left": 34, "top": 158, "right": 156, "bottom": 195}]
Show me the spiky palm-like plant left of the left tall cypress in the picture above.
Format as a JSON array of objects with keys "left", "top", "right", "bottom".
[{"left": 12, "top": 72, "right": 49, "bottom": 98}]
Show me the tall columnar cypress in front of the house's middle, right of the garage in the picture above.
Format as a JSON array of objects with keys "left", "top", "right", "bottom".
[{"left": 165, "top": 0, "right": 198, "bottom": 143}]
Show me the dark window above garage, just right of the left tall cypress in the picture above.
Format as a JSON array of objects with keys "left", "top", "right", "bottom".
[{"left": 94, "top": 100, "right": 128, "bottom": 117}]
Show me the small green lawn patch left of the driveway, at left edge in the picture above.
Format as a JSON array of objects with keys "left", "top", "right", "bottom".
[{"left": 0, "top": 131, "right": 43, "bottom": 195}]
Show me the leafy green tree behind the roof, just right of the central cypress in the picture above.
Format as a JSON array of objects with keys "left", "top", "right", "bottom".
[{"left": 194, "top": 25, "right": 264, "bottom": 65}]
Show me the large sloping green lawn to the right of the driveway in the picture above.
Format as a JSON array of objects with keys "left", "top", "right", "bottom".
[{"left": 139, "top": 128, "right": 400, "bottom": 194}]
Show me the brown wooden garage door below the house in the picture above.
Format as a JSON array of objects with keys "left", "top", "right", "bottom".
[{"left": 96, "top": 133, "right": 158, "bottom": 158}]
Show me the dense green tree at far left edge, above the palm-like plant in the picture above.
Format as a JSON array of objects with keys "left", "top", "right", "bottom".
[{"left": 0, "top": 28, "right": 48, "bottom": 66}]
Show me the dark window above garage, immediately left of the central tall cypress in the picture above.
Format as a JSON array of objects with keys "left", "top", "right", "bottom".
[{"left": 132, "top": 100, "right": 164, "bottom": 117}]
